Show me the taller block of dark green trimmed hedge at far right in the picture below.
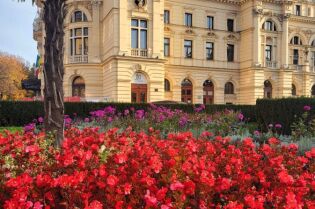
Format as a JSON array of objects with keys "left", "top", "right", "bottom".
[{"left": 256, "top": 97, "right": 315, "bottom": 135}]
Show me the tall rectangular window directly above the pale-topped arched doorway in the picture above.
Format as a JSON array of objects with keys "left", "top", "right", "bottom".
[{"left": 131, "top": 19, "right": 148, "bottom": 49}]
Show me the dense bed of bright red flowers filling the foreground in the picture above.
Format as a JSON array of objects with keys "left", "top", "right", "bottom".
[{"left": 0, "top": 129, "right": 315, "bottom": 209}]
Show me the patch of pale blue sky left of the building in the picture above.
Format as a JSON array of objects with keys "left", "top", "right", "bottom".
[{"left": 0, "top": 0, "right": 37, "bottom": 65}]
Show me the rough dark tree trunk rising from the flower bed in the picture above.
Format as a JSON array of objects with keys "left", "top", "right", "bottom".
[{"left": 44, "top": 0, "right": 66, "bottom": 147}]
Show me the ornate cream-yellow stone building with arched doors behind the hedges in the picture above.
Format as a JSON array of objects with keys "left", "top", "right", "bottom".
[{"left": 34, "top": 0, "right": 315, "bottom": 104}]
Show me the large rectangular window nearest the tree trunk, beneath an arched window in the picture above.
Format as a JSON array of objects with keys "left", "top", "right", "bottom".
[{"left": 70, "top": 27, "right": 89, "bottom": 56}]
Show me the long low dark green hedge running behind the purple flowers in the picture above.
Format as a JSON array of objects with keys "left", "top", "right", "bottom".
[{"left": 0, "top": 101, "right": 256, "bottom": 126}]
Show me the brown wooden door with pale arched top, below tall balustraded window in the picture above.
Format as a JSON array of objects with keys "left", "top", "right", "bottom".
[{"left": 131, "top": 72, "right": 148, "bottom": 103}]
